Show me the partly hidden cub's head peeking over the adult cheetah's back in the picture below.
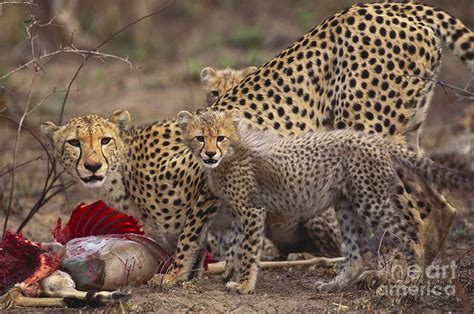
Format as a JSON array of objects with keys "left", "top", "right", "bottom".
[{"left": 201, "top": 66, "right": 257, "bottom": 103}]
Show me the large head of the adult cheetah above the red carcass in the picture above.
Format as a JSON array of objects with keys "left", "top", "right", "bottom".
[{"left": 41, "top": 110, "right": 130, "bottom": 188}]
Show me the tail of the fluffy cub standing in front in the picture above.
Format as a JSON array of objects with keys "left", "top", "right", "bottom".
[{"left": 392, "top": 150, "right": 474, "bottom": 195}]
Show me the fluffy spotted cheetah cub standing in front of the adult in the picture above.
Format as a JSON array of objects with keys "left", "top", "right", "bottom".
[{"left": 178, "top": 109, "right": 474, "bottom": 293}]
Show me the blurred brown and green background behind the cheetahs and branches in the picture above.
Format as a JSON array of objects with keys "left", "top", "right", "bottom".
[{"left": 0, "top": 0, "right": 474, "bottom": 239}]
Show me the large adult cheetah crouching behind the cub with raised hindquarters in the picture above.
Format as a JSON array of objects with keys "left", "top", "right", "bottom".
[{"left": 42, "top": 3, "right": 474, "bottom": 280}]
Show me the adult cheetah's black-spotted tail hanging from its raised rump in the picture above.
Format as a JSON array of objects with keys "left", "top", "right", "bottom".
[{"left": 398, "top": 3, "right": 474, "bottom": 73}]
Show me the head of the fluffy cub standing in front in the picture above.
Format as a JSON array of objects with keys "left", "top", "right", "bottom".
[{"left": 177, "top": 109, "right": 240, "bottom": 168}]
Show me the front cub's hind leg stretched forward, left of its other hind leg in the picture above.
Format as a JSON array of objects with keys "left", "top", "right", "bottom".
[{"left": 315, "top": 201, "right": 368, "bottom": 292}]
